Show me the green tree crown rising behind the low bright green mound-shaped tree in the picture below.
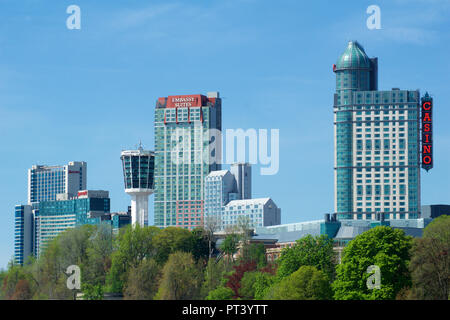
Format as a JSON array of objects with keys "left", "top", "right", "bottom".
[{"left": 277, "top": 235, "right": 335, "bottom": 279}]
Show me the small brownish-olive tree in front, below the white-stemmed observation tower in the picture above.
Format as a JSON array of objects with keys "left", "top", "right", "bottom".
[{"left": 124, "top": 259, "right": 161, "bottom": 300}]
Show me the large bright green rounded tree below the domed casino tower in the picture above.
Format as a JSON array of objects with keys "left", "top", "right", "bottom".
[{"left": 333, "top": 226, "right": 412, "bottom": 300}]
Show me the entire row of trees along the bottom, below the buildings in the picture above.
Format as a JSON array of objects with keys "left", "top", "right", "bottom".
[{"left": 0, "top": 216, "right": 450, "bottom": 300}]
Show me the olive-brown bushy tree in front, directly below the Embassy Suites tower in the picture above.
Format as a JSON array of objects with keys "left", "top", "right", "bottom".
[{"left": 155, "top": 252, "right": 202, "bottom": 300}]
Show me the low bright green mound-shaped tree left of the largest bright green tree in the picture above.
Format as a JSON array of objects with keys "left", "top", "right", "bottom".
[{"left": 266, "top": 266, "right": 332, "bottom": 300}]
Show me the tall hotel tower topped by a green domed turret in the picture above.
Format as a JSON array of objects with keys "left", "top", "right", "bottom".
[{"left": 333, "top": 41, "right": 420, "bottom": 220}]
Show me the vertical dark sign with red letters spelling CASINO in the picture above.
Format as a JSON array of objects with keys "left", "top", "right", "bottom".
[{"left": 421, "top": 92, "right": 433, "bottom": 171}]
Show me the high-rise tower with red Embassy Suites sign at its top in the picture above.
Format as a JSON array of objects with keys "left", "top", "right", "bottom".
[{"left": 155, "top": 92, "right": 222, "bottom": 228}]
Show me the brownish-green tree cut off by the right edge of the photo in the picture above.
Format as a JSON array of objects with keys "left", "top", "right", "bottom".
[{"left": 410, "top": 216, "right": 450, "bottom": 300}]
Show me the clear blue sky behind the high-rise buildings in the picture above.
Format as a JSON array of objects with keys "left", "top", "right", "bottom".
[{"left": 0, "top": 0, "right": 450, "bottom": 267}]
